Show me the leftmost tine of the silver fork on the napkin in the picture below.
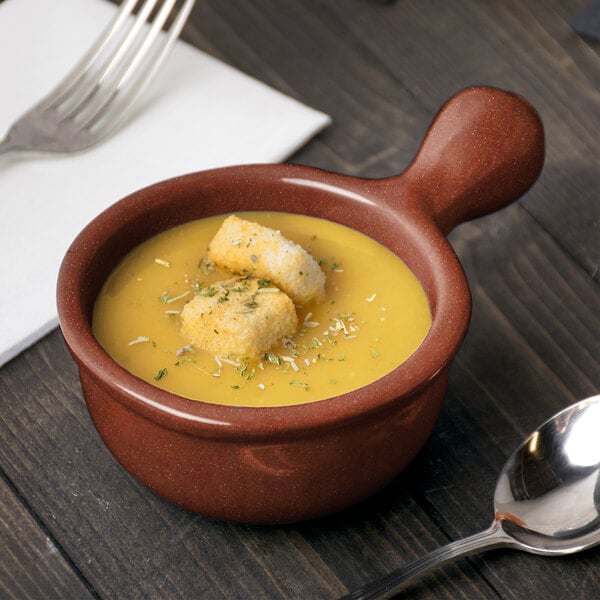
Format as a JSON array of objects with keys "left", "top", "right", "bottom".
[{"left": 37, "top": 0, "right": 139, "bottom": 109}]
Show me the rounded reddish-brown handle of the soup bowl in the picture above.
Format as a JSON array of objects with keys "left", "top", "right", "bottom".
[{"left": 388, "top": 87, "right": 544, "bottom": 234}]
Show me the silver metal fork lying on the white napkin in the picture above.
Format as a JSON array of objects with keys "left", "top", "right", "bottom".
[{"left": 0, "top": 0, "right": 195, "bottom": 154}]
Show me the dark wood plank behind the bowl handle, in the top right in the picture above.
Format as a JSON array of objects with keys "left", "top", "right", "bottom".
[{"left": 318, "top": 0, "right": 600, "bottom": 278}]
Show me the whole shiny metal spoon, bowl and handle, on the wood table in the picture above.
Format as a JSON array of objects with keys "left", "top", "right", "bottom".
[{"left": 342, "top": 395, "right": 600, "bottom": 600}]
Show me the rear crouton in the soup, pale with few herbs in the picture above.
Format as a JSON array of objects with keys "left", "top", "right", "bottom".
[{"left": 208, "top": 215, "right": 325, "bottom": 305}]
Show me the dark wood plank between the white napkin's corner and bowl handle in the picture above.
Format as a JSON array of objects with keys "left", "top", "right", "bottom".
[{"left": 185, "top": 0, "right": 434, "bottom": 176}]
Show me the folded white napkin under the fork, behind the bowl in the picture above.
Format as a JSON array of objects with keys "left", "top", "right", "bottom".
[{"left": 0, "top": 0, "right": 329, "bottom": 366}]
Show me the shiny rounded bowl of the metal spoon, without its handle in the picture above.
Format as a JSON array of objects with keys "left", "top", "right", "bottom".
[{"left": 494, "top": 395, "right": 600, "bottom": 554}]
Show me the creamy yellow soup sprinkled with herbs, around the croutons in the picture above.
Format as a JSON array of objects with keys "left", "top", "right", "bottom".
[{"left": 93, "top": 212, "right": 431, "bottom": 406}]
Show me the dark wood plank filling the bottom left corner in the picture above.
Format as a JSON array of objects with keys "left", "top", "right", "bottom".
[{"left": 0, "top": 478, "right": 94, "bottom": 600}]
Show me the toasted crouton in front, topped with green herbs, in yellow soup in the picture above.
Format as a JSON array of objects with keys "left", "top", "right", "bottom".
[{"left": 181, "top": 276, "right": 298, "bottom": 358}]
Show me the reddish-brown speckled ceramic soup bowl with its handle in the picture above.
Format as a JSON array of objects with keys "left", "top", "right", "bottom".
[{"left": 58, "top": 88, "right": 544, "bottom": 523}]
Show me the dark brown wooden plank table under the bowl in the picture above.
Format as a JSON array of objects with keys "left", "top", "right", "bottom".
[{"left": 0, "top": 0, "right": 600, "bottom": 600}]
